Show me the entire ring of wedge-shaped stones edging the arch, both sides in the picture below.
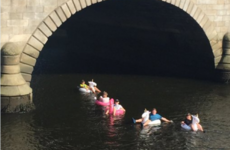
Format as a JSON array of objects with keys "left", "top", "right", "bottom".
[{"left": 20, "top": 0, "right": 219, "bottom": 83}]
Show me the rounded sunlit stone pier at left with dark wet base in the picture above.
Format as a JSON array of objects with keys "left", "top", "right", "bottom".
[{"left": 1, "top": 43, "right": 34, "bottom": 113}]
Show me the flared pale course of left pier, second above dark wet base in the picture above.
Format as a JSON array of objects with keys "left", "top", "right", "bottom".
[{"left": 1, "top": 73, "right": 26, "bottom": 85}]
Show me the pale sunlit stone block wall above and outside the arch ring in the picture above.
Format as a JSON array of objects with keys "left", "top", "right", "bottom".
[{"left": 1, "top": 0, "right": 230, "bottom": 46}]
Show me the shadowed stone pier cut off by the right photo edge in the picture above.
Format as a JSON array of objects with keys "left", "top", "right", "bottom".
[{"left": 216, "top": 32, "right": 230, "bottom": 83}]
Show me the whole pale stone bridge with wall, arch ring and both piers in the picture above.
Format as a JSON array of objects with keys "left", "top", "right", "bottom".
[{"left": 1, "top": 0, "right": 230, "bottom": 112}]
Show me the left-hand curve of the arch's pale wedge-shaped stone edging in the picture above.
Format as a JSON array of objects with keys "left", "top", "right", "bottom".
[{"left": 20, "top": 0, "right": 102, "bottom": 84}]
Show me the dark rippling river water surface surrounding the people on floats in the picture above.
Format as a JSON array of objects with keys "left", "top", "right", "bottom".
[{"left": 1, "top": 74, "right": 230, "bottom": 150}]
